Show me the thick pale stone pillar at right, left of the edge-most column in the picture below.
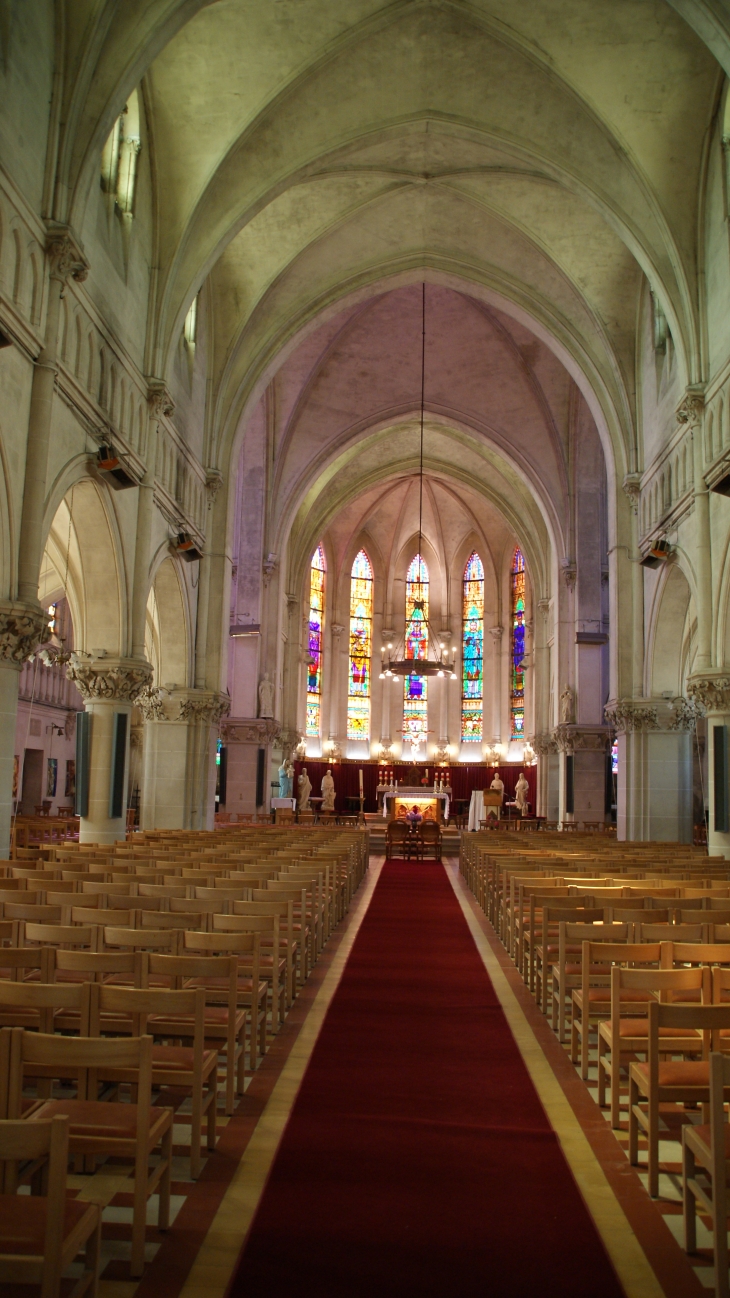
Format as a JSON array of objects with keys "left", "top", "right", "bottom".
[{"left": 605, "top": 698, "right": 692, "bottom": 842}]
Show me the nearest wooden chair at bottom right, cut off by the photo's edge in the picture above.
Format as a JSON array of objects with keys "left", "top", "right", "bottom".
[{"left": 682, "top": 1051, "right": 730, "bottom": 1298}]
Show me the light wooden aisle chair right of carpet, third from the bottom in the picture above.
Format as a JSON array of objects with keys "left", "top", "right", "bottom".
[{"left": 598, "top": 964, "right": 712, "bottom": 1127}]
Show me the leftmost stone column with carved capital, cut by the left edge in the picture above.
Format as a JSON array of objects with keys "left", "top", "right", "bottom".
[{"left": 0, "top": 600, "right": 48, "bottom": 861}]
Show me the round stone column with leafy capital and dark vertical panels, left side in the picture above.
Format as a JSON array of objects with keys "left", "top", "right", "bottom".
[{"left": 66, "top": 653, "right": 152, "bottom": 842}]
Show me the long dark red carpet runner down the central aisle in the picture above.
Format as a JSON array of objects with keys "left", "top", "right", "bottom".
[{"left": 230, "top": 861, "right": 623, "bottom": 1298}]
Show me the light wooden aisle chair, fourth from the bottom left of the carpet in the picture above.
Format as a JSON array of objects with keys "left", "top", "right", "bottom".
[{"left": 142, "top": 953, "right": 248, "bottom": 1116}]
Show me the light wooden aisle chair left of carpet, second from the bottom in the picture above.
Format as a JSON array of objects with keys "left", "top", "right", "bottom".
[{"left": 8, "top": 1028, "right": 173, "bottom": 1276}]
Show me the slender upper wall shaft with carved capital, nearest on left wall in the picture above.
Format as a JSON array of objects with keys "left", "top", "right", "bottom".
[{"left": 18, "top": 226, "right": 88, "bottom": 606}]
